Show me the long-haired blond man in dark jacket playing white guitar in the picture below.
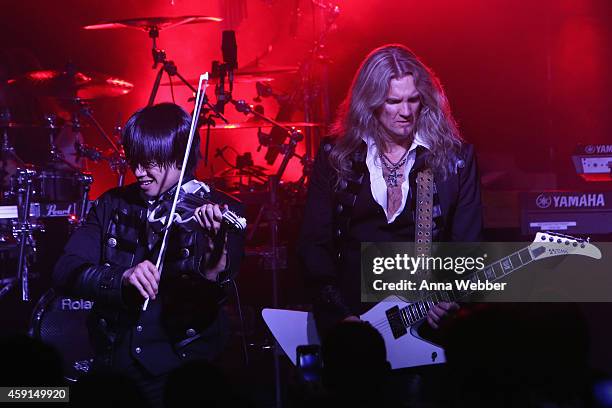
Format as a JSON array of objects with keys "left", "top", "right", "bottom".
[{"left": 298, "top": 44, "right": 482, "bottom": 335}]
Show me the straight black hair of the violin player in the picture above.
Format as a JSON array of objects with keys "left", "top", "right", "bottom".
[{"left": 122, "top": 103, "right": 200, "bottom": 175}]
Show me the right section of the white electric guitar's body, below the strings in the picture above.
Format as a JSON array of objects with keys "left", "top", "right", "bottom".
[{"left": 360, "top": 296, "right": 446, "bottom": 369}]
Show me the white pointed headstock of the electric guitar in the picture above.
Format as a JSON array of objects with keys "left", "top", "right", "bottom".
[{"left": 529, "top": 231, "right": 601, "bottom": 259}]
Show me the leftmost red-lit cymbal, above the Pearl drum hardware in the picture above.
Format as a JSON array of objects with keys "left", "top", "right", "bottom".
[{"left": 8, "top": 70, "right": 134, "bottom": 99}]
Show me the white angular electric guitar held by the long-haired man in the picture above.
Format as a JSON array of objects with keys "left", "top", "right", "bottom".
[{"left": 262, "top": 232, "right": 601, "bottom": 369}]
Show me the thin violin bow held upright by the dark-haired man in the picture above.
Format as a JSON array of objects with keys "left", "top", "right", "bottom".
[{"left": 142, "top": 72, "right": 208, "bottom": 311}]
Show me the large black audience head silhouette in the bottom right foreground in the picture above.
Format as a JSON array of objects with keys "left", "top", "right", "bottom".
[{"left": 445, "top": 303, "right": 588, "bottom": 406}]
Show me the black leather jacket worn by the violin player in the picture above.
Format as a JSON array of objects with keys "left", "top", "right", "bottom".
[{"left": 53, "top": 184, "right": 244, "bottom": 375}]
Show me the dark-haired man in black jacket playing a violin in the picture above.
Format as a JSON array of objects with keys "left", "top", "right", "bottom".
[{"left": 53, "top": 103, "right": 244, "bottom": 406}]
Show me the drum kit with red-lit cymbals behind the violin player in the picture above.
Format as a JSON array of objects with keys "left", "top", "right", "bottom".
[{"left": 0, "top": 12, "right": 334, "bottom": 379}]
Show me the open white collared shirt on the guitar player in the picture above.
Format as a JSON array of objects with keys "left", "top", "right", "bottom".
[{"left": 364, "top": 133, "right": 429, "bottom": 224}]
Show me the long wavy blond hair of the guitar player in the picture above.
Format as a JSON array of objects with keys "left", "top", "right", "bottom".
[{"left": 329, "top": 44, "right": 462, "bottom": 182}]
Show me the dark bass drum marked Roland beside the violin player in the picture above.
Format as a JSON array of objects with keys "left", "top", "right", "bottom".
[{"left": 30, "top": 289, "right": 94, "bottom": 381}]
